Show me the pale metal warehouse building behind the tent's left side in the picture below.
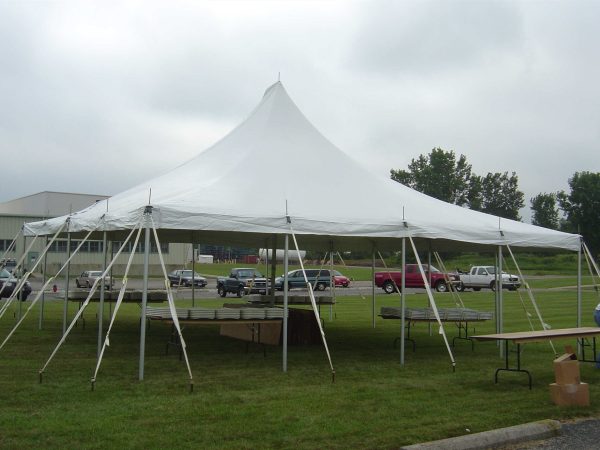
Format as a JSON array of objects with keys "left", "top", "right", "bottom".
[{"left": 0, "top": 191, "right": 191, "bottom": 275}]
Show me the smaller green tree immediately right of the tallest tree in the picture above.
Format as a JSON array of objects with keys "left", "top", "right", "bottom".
[{"left": 481, "top": 172, "right": 525, "bottom": 220}]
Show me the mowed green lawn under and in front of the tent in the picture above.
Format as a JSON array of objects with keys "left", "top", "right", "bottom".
[{"left": 0, "top": 284, "right": 600, "bottom": 449}]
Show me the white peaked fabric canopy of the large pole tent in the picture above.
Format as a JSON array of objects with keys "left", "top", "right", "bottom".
[{"left": 24, "top": 82, "right": 580, "bottom": 250}]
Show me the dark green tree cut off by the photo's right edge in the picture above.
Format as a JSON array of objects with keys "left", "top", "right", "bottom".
[{"left": 557, "top": 172, "right": 600, "bottom": 255}]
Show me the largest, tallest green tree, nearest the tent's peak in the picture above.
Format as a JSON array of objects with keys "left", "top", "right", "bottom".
[{"left": 390, "top": 148, "right": 472, "bottom": 206}]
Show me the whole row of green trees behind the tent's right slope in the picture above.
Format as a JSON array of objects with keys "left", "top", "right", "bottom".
[{"left": 390, "top": 148, "right": 600, "bottom": 254}]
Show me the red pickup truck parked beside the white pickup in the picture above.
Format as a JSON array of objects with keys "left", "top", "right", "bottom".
[{"left": 375, "top": 264, "right": 460, "bottom": 294}]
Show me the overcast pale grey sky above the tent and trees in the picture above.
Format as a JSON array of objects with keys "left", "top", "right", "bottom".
[{"left": 0, "top": 0, "right": 600, "bottom": 219}]
